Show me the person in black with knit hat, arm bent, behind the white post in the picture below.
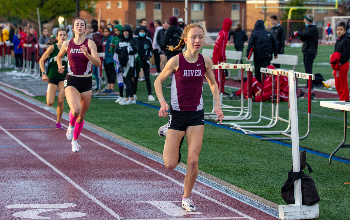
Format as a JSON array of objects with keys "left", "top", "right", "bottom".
[{"left": 293, "top": 14, "right": 318, "bottom": 98}]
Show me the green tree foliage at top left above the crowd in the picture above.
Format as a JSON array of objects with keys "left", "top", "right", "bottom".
[{"left": 0, "top": 0, "right": 97, "bottom": 24}]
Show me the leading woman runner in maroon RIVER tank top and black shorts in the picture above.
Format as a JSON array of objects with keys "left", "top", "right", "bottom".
[{"left": 154, "top": 24, "right": 224, "bottom": 211}]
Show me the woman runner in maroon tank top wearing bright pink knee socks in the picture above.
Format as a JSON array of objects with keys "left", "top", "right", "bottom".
[{"left": 57, "top": 18, "right": 101, "bottom": 152}]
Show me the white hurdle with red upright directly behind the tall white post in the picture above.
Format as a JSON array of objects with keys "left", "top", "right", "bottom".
[{"left": 260, "top": 71, "right": 315, "bottom": 141}]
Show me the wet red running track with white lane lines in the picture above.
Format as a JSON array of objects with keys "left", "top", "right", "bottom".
[{"left": 0, "top": 90, "right": 277, "bottom": 219}]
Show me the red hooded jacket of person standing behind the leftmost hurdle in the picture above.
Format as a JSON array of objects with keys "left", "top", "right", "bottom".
[{"left": 213, "top": 18, "right": 232, "bottom": 63}]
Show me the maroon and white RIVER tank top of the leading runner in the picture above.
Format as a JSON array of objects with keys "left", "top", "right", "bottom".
[{"left": 171, "top": 53, "right": 206, "bottom": 111}]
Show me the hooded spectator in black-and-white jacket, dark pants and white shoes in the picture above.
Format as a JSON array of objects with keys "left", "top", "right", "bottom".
[{"left": 115, "top": 25, "right": 138, "bottom": 105}]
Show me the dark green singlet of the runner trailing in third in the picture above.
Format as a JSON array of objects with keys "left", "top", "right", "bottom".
[{"left": 47, "top": 44, "right": 68, "bottom": 79}]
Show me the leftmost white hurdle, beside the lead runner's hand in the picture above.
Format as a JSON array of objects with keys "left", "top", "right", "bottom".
[{"left": 204, "top": 63, "right": 252, "bottom": 120}]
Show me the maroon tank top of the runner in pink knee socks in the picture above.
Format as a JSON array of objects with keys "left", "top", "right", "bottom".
[{"left": 67, "top": 38, "right": 92, "bottom": 75}]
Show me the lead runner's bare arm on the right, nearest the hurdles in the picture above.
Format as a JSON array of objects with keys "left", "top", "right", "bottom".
[{"left": 203, "top": 56, "right": 224, "bottom": 124}]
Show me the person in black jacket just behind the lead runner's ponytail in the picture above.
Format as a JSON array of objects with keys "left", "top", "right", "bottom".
[{"left": 164, "top": 16, "right": 182, "bottom": 60}]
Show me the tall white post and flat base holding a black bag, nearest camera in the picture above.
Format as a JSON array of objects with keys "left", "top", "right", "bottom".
[{"left": 278, "top": 70, "right": 319, "bottom": 219}]
